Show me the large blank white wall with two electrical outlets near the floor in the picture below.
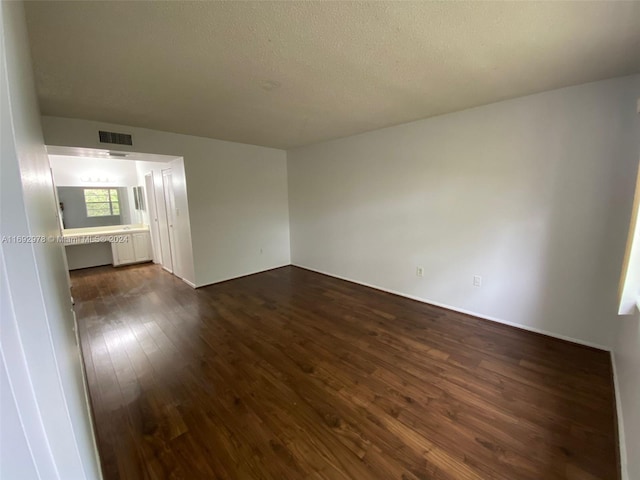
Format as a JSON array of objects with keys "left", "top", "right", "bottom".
[{"left": 288, "top": 76, "right": 640, "bottom": 347}]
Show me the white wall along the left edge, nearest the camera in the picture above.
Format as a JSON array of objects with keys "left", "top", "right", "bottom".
[{"left": 0, "top": 2, "right": 100, "bottom": 479}]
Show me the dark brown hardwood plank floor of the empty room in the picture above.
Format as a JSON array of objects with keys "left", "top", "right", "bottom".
[{"left": 72, "top": 265, "right": 618, "bottom": 480}]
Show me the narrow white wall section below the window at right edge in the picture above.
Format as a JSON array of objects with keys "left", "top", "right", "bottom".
[{"left": 614, "top": 310, "right": 640, "bottom": 480}]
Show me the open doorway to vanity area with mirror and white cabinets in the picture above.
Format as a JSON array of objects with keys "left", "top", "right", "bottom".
[{"left": 47, "top": 146, "right": 194, "bottom": 287}]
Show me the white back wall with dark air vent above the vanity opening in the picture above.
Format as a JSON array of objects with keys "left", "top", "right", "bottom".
[{"left": 42, "top": 117, "right": 290, "bottom": 286}]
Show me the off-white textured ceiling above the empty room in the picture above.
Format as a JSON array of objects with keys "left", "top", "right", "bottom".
[{"left": 26, "top": 1, "right": 640, "bottom": 148}]
